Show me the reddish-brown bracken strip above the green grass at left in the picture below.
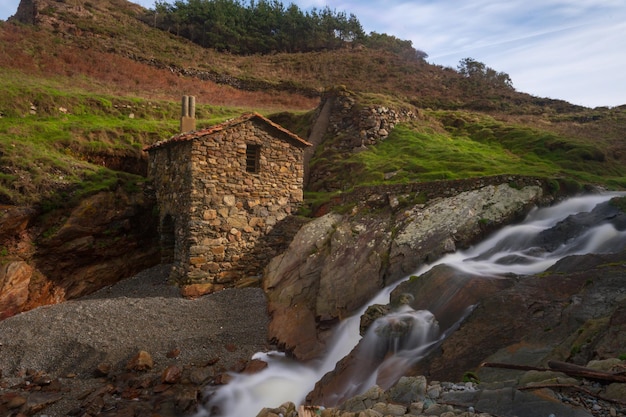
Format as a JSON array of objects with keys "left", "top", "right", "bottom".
[{"left": 0, "top": 23, "right": 318, "bottom": 110}]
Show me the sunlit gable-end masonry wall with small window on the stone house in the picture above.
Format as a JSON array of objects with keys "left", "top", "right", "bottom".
[{"left": 184, "top": 119, "right": 303, "bottom": 291}]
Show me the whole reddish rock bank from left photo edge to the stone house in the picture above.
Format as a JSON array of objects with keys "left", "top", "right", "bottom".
[{"left": 0, "top": 190, "right": 160, "bottom": 319}]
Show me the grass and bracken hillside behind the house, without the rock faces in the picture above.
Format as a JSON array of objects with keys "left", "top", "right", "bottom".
[{"left": 0, "top": 0, "right": 626, "bottom": 208}]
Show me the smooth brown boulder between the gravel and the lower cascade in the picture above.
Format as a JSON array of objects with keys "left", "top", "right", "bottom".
[{"left": 264, "top": 214, "right": 391, "bottom": 359}]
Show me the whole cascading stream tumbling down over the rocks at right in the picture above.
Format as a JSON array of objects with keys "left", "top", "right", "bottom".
[{"left": 199, "top": 193, "right": 626, "bottom": 417}]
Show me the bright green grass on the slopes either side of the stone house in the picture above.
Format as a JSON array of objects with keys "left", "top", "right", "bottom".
[{"left": 0, "top": 71, "right": 626, "bottom": 208}]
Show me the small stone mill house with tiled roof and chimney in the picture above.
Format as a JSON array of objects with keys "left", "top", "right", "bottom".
[{"left": 145, "top": 96, "right": 310, "bottom": 295}]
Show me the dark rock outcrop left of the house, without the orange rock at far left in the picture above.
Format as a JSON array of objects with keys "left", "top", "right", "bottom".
[{"left": 29, "top": 189, "right": 160, "bottom": 299}]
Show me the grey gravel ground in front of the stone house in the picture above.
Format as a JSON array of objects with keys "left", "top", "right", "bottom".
[{"left": 0, "top": 265, "right": 270, "bottom": 415}]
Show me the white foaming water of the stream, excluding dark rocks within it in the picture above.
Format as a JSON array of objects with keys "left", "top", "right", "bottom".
[{"left": 198, "top": 193, "right": 626, "bottom": 417}]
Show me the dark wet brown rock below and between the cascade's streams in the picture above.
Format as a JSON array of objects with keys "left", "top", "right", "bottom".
[{"left": 307, "top": 198, "right": 626, "bottom": 404}]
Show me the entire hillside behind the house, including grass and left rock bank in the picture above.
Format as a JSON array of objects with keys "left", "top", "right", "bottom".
[{"left": 0, "top": 0, "right": 626, "bottom": 306}]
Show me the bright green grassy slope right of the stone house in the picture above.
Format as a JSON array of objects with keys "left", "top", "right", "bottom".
[{"left": 333, "top": 111, "right": 626, "bottom": 188}]
